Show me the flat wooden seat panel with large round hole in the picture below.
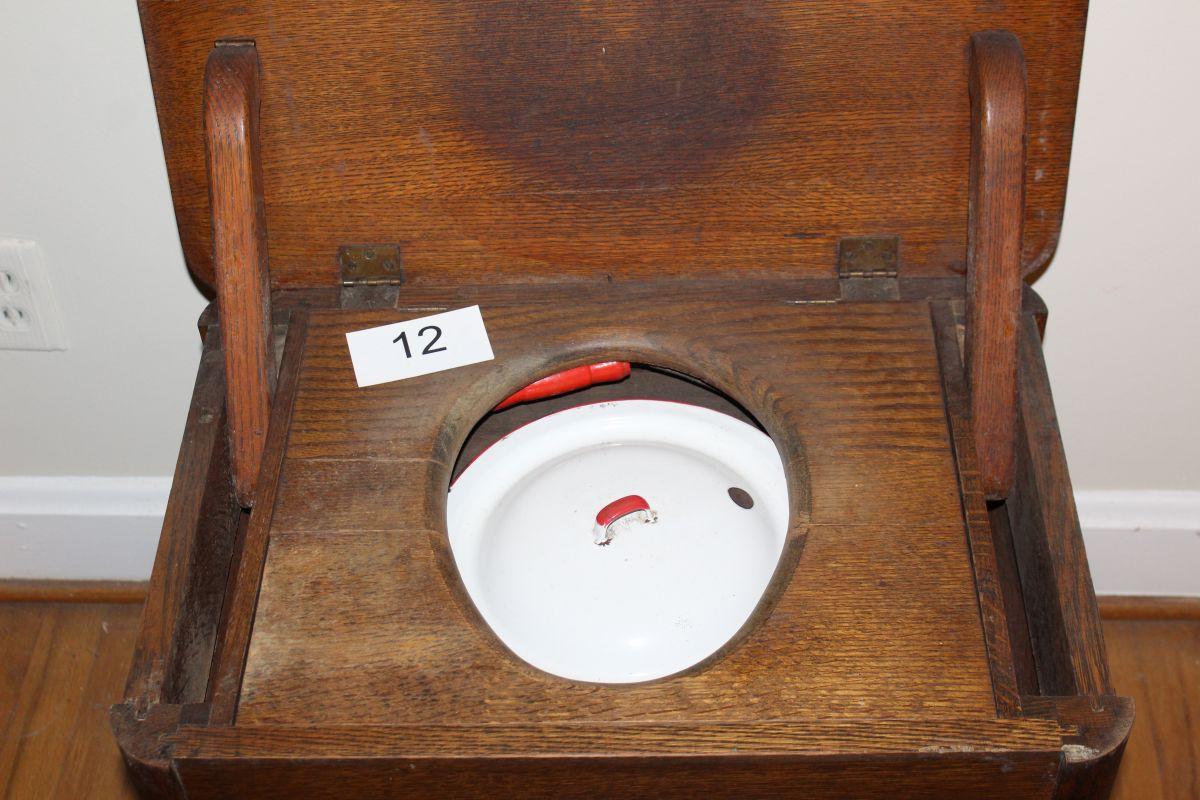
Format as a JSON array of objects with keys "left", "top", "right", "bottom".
[{"left": 229, "top": 297, "right": 995, "bottom": 726}]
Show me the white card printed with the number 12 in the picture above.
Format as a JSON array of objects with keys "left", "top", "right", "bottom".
[{"left": 346, "top": 306, "right": 496, "bottom": 386}]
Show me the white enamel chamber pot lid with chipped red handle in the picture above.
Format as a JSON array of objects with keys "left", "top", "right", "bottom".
[{"left": 446, "top": 399, "right": 788, "bottom": 684}]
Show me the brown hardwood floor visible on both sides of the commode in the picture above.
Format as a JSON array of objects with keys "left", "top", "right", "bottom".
[{"left": 0, "top": 595, "right": 1200, "bottom": 800}]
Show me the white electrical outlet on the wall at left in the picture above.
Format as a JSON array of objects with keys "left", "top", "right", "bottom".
[{"left": 0, "top": 237, "right": 67, "bottom": 350}]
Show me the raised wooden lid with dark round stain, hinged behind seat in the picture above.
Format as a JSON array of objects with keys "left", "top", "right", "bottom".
[{"left": 140, "top": 0, "right": 1086, "bottom": 287}]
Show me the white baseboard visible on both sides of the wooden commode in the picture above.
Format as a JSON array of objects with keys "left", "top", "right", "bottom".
[{"left": 0, "top": 476, "right": 1200, "bottom": 597}]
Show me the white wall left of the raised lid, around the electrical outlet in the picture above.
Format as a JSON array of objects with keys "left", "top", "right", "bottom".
[{"left": 0, "top": 0, "right": 204, "bottom": 476}]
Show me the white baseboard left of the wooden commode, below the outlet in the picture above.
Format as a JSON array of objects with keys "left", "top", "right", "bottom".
[{"left": 0, "top": 476, "right": 170, "bottom": 581}]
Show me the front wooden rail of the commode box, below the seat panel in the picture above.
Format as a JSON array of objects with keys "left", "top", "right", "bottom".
[{"left": 171, "top": 720, "right": 1058, "bottom": 798}]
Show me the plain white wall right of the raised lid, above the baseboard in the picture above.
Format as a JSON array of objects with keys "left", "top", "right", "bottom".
[{"left": 1036, "top": 0, "right": 1200, "bottom": 491}]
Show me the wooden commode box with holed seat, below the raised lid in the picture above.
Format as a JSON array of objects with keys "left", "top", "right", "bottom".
[{"left": 113, "top": 282, "right": 1132, "bottom": 798}]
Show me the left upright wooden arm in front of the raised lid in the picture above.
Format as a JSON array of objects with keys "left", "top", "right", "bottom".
[{"left": 204, "top": 42, "right": 275, "bottom": 507}]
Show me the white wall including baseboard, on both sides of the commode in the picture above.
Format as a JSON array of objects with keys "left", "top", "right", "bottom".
[{"left": 0, "top": 0, "right": 1200, "bottom": 594}]
